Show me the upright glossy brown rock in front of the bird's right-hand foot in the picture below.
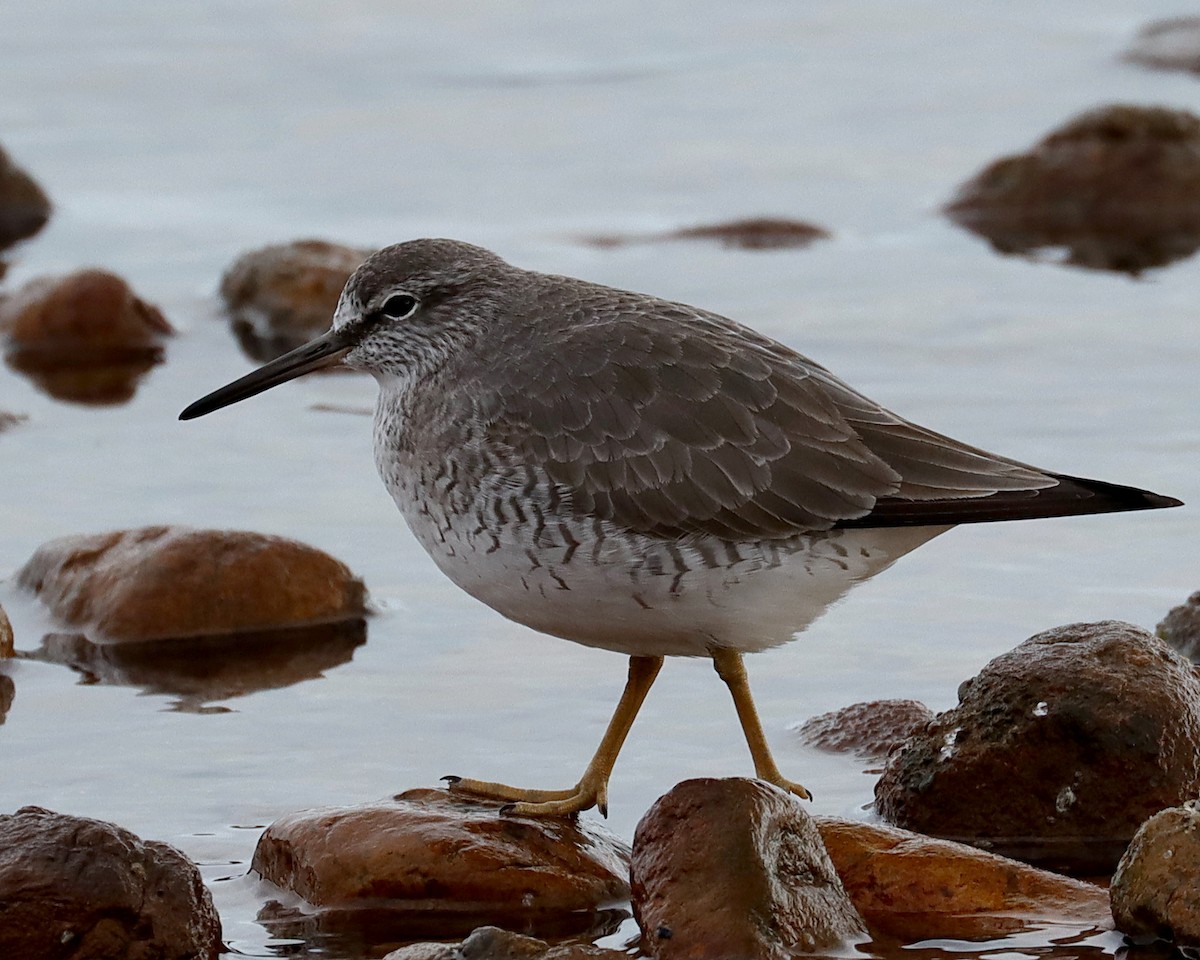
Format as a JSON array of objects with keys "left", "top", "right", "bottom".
[{"left": 630, "top": 778, "right": 865, "bottom": 960}]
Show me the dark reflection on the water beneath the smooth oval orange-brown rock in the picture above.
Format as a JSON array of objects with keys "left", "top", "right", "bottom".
[{"left": 25, "top": 619, "right": 367, "bottom": 713}]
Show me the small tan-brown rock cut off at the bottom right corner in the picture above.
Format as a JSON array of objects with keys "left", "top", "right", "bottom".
[{"left": 1110, "top": 800, "right": 1200, "bottom": 947}]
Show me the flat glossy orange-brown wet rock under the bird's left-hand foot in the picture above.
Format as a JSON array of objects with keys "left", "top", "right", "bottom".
[{"left": 252, "top": 790, "right": 629, "bottom": 943}]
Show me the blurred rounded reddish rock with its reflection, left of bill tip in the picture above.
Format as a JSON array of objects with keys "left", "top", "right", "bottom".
[{"left": 0, "top": 270, "right": 174, "bottom": 404}]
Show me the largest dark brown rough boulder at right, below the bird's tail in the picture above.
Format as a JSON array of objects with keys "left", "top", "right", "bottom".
[{"left": 875, "top": 620, "right": 1200, "bottom": 875}]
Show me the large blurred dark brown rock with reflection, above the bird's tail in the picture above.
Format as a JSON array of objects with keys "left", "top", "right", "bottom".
[{"left": 946, "top": 106, "right": 1200, "bottom": 275}]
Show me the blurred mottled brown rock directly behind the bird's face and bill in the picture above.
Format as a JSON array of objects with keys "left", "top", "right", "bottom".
[{"left": 221, "top": 240, "right": 374, "bottom": 362}]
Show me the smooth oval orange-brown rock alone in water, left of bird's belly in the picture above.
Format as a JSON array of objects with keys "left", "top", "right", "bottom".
[{"left": 17, "top": 527, "right": 365, "bottom": 643}]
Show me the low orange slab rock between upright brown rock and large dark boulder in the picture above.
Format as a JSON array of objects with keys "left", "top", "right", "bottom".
[{"left": 815, "top": 817, "right": 1112, "bottom": 942}]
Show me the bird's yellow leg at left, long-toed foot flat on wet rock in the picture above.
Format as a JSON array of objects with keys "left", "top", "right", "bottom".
[{"left": 444, "top": 656, "right": 662, "bottom": 816}]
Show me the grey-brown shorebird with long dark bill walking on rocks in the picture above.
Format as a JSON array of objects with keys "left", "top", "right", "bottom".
[{"left": 180, "top": 239, "right": 1181, "bottom": 816}]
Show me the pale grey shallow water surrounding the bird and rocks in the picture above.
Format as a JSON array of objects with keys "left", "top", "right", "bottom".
[{"left": 0, "top": 0, "right": 1200, "bottom": 955}]
